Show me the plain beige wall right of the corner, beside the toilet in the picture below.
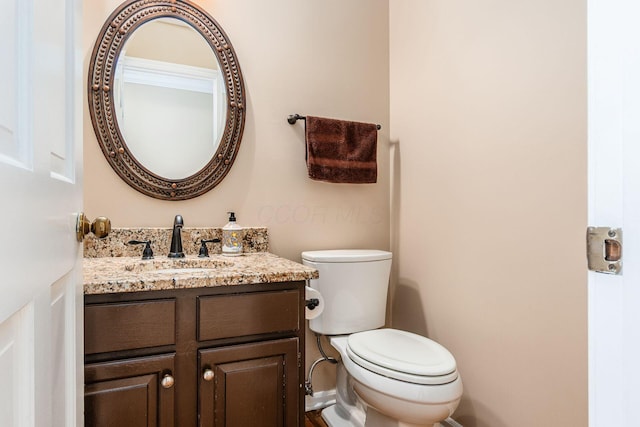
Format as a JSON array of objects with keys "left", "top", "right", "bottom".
[{"left": 389, "top": 0, "right": 588, "bottom": 427}]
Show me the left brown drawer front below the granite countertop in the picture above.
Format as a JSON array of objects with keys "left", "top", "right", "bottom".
[{"left": 84, "top": 299, "right": 176, "bottom": 354}]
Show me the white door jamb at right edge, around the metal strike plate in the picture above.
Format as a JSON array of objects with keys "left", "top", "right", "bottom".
[{"left": 588, "top": 0, "right": 640, "bottom": 427}]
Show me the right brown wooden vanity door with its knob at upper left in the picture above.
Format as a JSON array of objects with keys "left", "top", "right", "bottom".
[{"left": 199, "top": 338, "right": 301, "bottom": 427}]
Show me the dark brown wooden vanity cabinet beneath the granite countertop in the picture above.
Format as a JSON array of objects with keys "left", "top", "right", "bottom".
[{"left": 85, "top": 282, "right": 304, "bottom": 427}]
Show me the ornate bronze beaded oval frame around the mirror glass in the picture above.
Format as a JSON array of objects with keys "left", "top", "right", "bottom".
[{"left": 88, "top": 0, "right": 246, "bottom": 200}]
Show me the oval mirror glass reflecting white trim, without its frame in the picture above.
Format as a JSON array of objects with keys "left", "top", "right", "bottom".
[{"left": 114, "top": 18, "right": 226, "bottom": 179}]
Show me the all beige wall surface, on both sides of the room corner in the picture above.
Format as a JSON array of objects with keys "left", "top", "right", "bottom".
[{"left": 84, "top": 0, "right": 587, "bottom": 427}]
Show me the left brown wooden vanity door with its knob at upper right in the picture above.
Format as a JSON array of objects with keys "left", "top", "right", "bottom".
[{"left": 84, "top": 354, "right": 175, "bottom": 427}]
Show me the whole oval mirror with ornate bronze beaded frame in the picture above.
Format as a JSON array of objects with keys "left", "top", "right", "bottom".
[{"left": 89, "top": 0, "right": 245, "bottom": 200}]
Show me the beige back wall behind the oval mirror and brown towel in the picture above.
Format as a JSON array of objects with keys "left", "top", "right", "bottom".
[{"left": 83, "top": 0, "right": 389, "bottom": 390}]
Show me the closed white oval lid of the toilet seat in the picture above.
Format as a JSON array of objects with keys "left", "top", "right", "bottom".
[{"left": 347, "top": 329, "right": 458, "bottom": 384}]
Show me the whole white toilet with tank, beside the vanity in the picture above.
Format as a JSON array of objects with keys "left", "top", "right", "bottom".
[{"left": 302, "top": 250, "right": 462, "bottom": 427}]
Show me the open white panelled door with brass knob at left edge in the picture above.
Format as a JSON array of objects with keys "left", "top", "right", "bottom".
[{"left": 0, "top": 0, "right": 83, "bottom": 427}]
